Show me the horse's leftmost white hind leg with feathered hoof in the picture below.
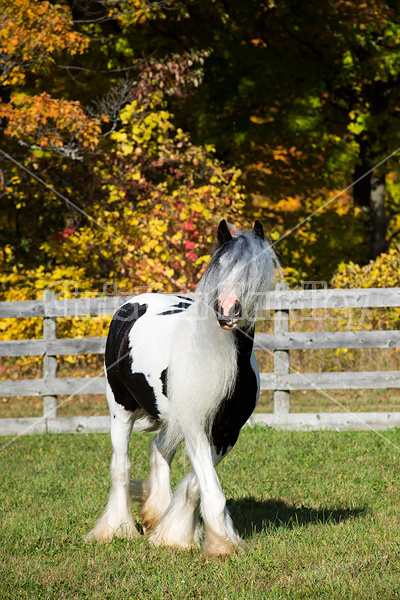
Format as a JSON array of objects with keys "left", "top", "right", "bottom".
[{"left": 86, "top": 384, "right": 139, "bottom": 541}]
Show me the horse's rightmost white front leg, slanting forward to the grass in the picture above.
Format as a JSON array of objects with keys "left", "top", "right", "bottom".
[{"left": 185, "top": 433, "right": 242, "bottom": 558}]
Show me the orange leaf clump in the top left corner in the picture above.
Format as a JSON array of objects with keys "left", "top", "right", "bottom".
[{"left": 0, "top": 0, "right": 89, "bottom": 85}]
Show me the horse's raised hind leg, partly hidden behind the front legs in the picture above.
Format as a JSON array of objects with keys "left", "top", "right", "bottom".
[{"left": 131, "top": 432, "right": 175, "bottom": 531}]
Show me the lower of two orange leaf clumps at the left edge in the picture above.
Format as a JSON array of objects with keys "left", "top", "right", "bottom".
[{"left": 0, "top": 93, "right": 101, "bottom": 157}]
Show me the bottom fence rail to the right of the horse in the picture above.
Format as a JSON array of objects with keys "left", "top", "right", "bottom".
[{"left": 247, "top": 412, "right": 400, "bottom": 431}]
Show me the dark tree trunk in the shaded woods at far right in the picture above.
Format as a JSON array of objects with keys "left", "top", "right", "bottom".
[{"left": 353, "top": 140, "right": 388, "bottom": 260}]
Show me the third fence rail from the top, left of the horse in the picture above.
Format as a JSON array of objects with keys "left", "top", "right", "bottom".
[{"left": 0, "top": 377, "right": 105, "bottom": 397}]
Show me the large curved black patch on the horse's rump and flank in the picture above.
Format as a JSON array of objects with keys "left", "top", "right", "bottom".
[{"left": 105, "top": 302, "right": 159, "bottom": 419}]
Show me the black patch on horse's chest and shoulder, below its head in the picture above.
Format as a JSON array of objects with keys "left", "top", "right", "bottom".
[{"left": 211, "top": 328, "right": 257, "bottom": 455}]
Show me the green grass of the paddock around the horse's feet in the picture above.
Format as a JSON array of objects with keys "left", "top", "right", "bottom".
[{"left": 0, "top": 427, "right": 400, "bottom": 600}]
